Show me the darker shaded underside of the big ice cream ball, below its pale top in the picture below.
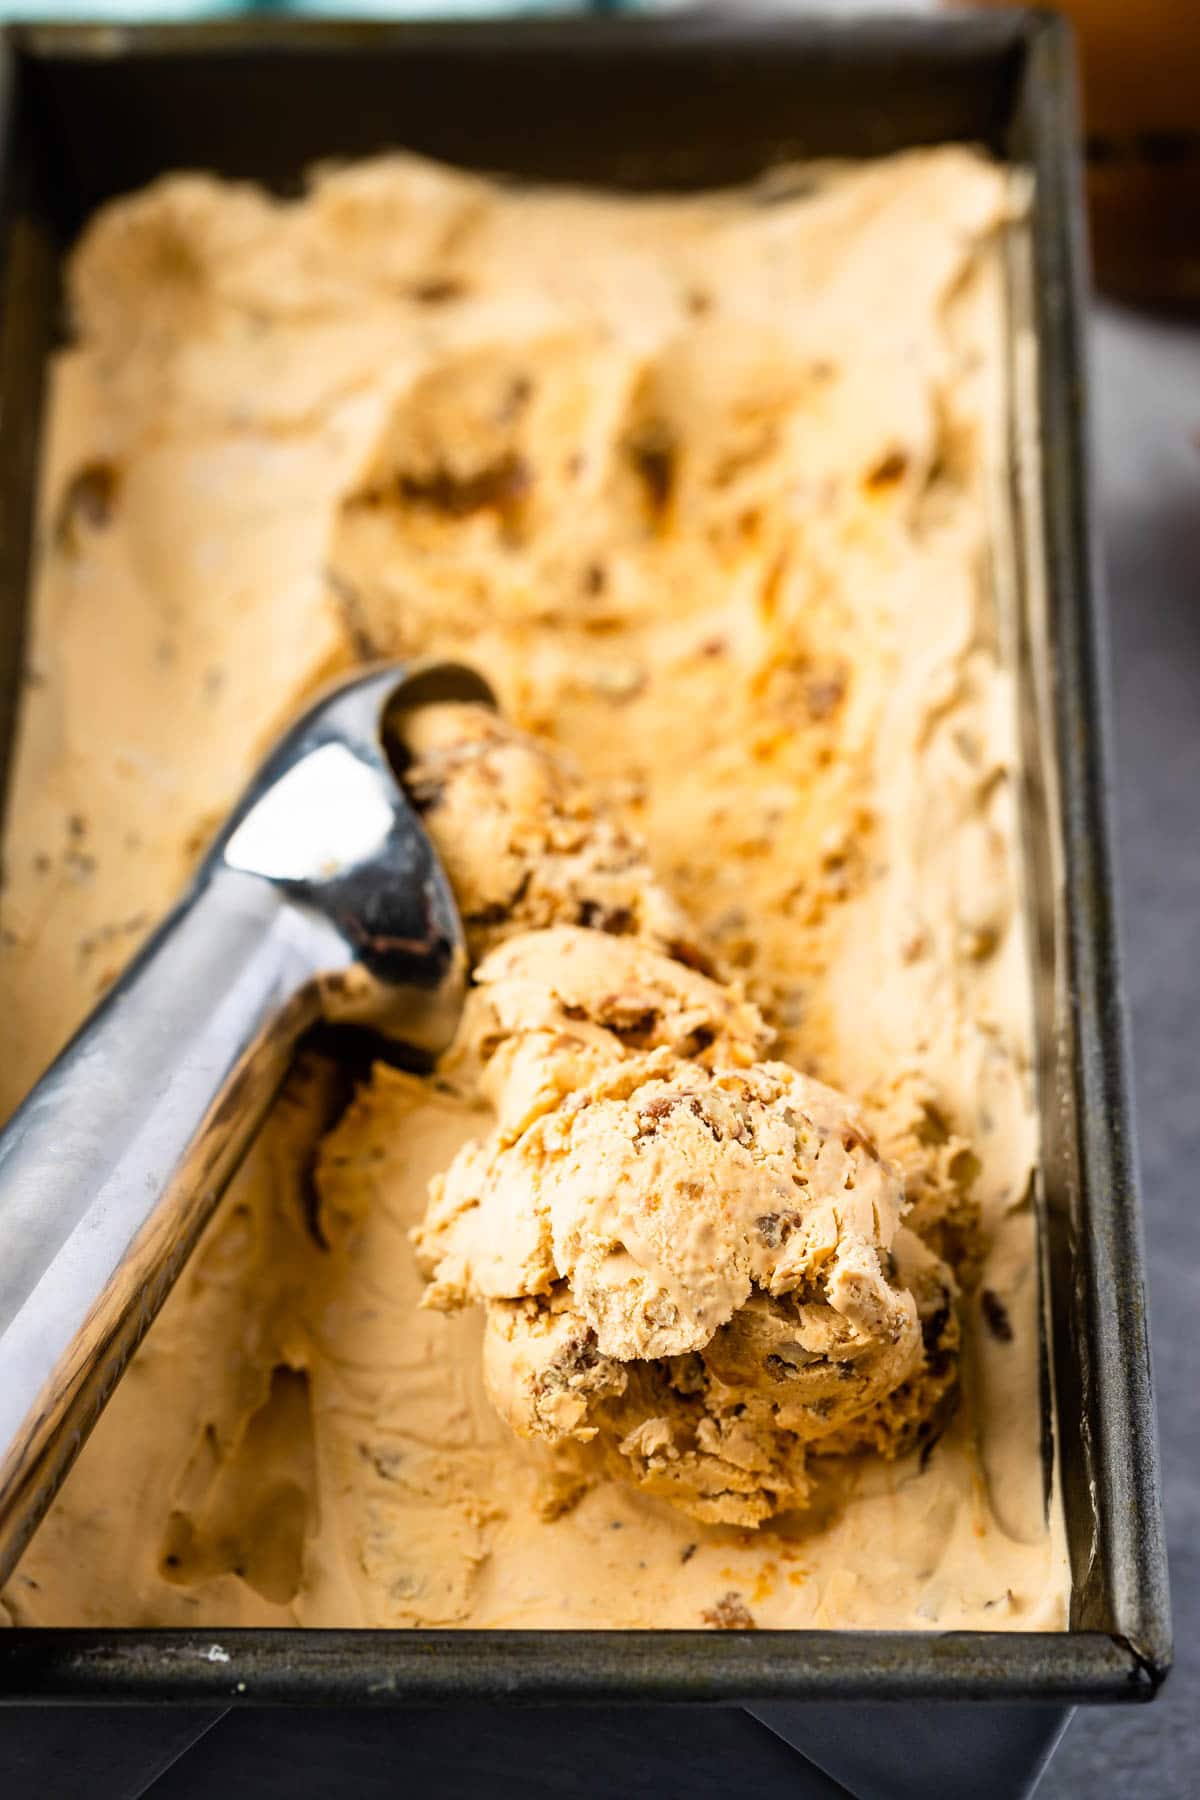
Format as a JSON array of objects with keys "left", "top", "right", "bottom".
[{"left": 471, "top": 1226, "right": 959, "bottom": 1526}]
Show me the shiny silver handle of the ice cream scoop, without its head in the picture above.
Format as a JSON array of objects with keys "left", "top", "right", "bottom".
[{"left": 0, "top": 868, "right": 329, "bottom": 1586}]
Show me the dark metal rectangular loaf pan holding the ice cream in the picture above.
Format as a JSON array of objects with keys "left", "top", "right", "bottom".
[{"left": 0, "top": 13, "right": 1169, "bottom": 1706}]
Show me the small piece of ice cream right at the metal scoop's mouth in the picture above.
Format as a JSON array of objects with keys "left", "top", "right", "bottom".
[{"left": 405, "top": 704, "right": 707, "bottom": 968}]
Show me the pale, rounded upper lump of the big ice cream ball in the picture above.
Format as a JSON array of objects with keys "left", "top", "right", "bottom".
[{"left": 419, "top": 1049, "right": 916, "bottom": 1361}]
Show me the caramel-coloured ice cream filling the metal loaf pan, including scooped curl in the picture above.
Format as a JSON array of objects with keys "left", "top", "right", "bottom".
[{"left": 0, "top": 148, "right": 1067, "bottom": 1629}]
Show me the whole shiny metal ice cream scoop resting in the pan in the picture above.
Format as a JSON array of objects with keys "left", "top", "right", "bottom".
[{"left": 0, "top": 664, "right": 491, "bottom": 1584}]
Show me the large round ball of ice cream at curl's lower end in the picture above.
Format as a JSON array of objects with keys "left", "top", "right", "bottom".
[{"left": 417, "top": 1008, "right": 923, "bottom": 1525}]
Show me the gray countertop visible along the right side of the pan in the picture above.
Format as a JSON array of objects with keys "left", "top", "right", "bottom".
[{"left": 1038, "top": 306, "right": 1200, "bottom": 1800}]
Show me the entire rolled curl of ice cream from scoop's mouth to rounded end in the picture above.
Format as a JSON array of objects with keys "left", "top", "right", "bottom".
[{"left": 410, "top": 707, "right": 957, "bottom": 1525}]
